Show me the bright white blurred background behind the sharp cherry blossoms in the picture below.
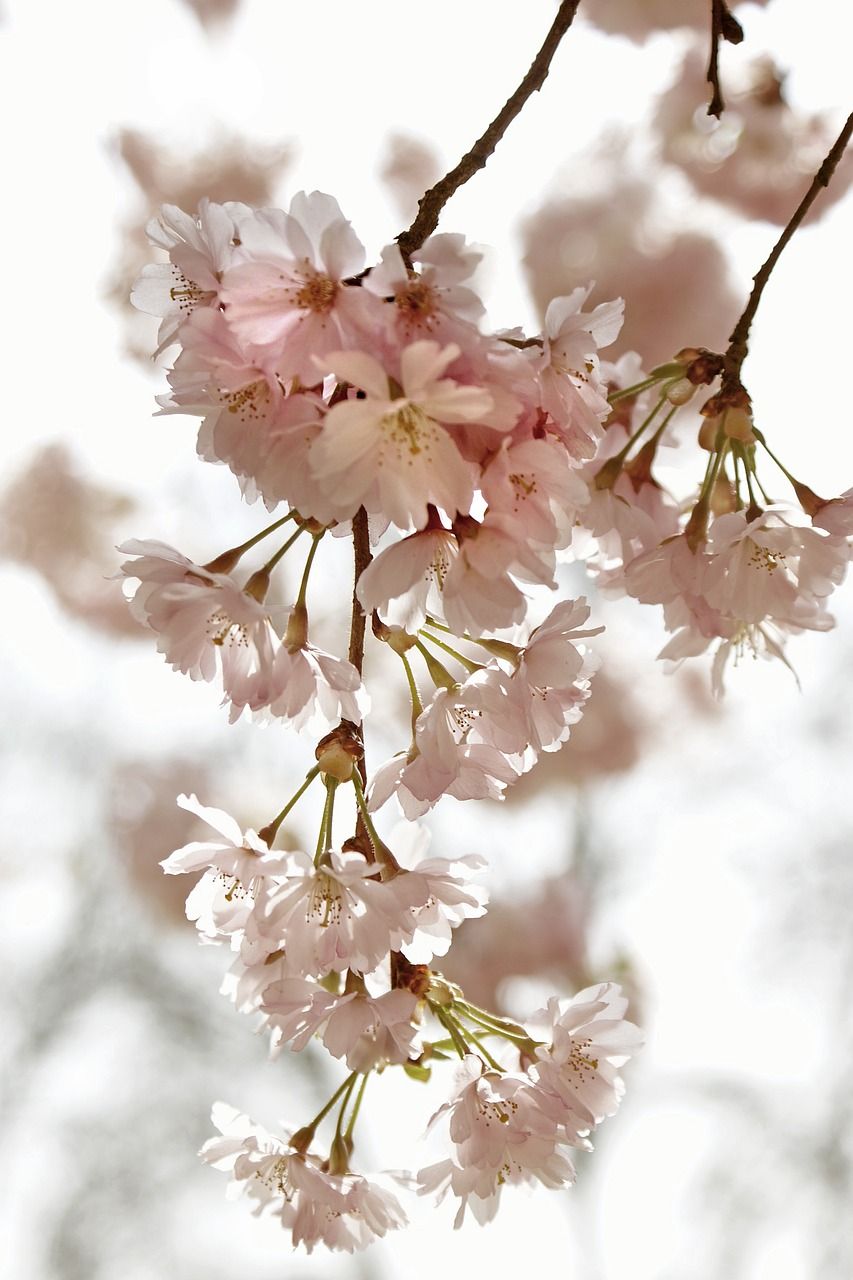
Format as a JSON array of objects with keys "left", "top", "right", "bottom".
[{"left": 0, "top": 0, "right": 853, "bottom": 1280}]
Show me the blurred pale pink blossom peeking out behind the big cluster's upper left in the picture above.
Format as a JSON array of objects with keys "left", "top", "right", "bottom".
[{"left": 106, "top": 129, "right": 292, "bottom": 364}]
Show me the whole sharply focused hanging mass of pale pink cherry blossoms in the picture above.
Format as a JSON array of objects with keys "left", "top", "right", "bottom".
[{"left": 120, "top": 180, "right": 853, "bottom": 1251}]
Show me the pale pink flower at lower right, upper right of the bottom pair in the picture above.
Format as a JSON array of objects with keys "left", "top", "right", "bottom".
[{"left": 532, "top": 982, "right": 643, "bottom": 1142}]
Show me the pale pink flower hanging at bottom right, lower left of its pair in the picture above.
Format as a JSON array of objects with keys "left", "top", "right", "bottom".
[{"left": 416, "top": 1055, "right": 575, "bottom": 1228}]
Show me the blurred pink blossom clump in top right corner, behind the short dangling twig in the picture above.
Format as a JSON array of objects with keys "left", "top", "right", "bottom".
[{"left": 654, "top": 44, "right": 853, "bottom": 227}]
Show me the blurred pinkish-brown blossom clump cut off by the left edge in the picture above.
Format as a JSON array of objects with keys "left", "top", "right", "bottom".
[{"left": 0, "top": 444, "right": 138, "bottom": 635}]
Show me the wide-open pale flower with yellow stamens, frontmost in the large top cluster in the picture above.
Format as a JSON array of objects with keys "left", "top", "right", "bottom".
[{"left": 311, "top": 340, "right": 493, "bottom": 530}]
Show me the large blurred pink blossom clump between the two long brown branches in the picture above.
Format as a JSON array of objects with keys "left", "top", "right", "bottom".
[{"left": 523, "top": 162, "right": 739, "bottom": 366}]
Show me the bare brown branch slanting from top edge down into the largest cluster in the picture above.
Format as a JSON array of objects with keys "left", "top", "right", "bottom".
[{"left": 397, "top": 0, "right": 580, "bottom": 260}]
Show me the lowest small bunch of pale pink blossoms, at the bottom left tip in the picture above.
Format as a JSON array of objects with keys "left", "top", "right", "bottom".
[{"left": 200, "top": 1102, "right": 406, "bottom": 1253}]
